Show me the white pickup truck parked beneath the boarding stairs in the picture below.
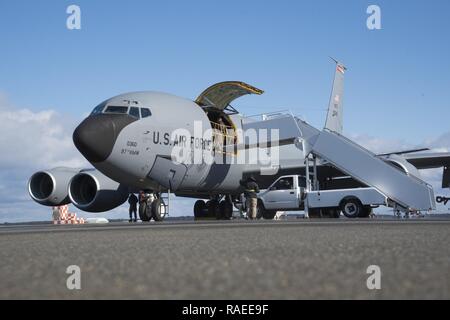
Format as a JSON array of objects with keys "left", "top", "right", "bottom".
[{"left": 258, "top": 175, "right": 387, "bottom": 219}]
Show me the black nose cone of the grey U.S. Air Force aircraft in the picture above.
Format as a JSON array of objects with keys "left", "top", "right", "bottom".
[{"left": 73, "top": 114, "right": 136, "bottom": 162}]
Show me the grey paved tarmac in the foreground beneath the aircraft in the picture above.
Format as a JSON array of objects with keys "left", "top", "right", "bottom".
[{"left": 0, "top": 219, "right": 450, "bottom": 299}]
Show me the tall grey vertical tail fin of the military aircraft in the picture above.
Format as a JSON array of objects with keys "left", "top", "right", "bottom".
[{"left": 325, "top": 58, "right": 347, "bottom": 133}]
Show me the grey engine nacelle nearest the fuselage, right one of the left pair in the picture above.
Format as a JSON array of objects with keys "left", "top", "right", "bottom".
[{"left": 69, "top": 170, "right": 129, "bottom": 212}]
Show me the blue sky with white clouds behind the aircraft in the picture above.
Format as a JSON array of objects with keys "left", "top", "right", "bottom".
[{"left": 0, "top": 0, "right": 450, "bottom": 222}]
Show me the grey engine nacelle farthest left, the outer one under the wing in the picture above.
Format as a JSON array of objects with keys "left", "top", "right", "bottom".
[{"left": 28, "top": 167, "right": 80, "bottom": 206}]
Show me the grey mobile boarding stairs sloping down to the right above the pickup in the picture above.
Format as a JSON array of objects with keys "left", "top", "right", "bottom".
[{"left": 243, "top": 112, "right": 436, "bottom": 212}]
